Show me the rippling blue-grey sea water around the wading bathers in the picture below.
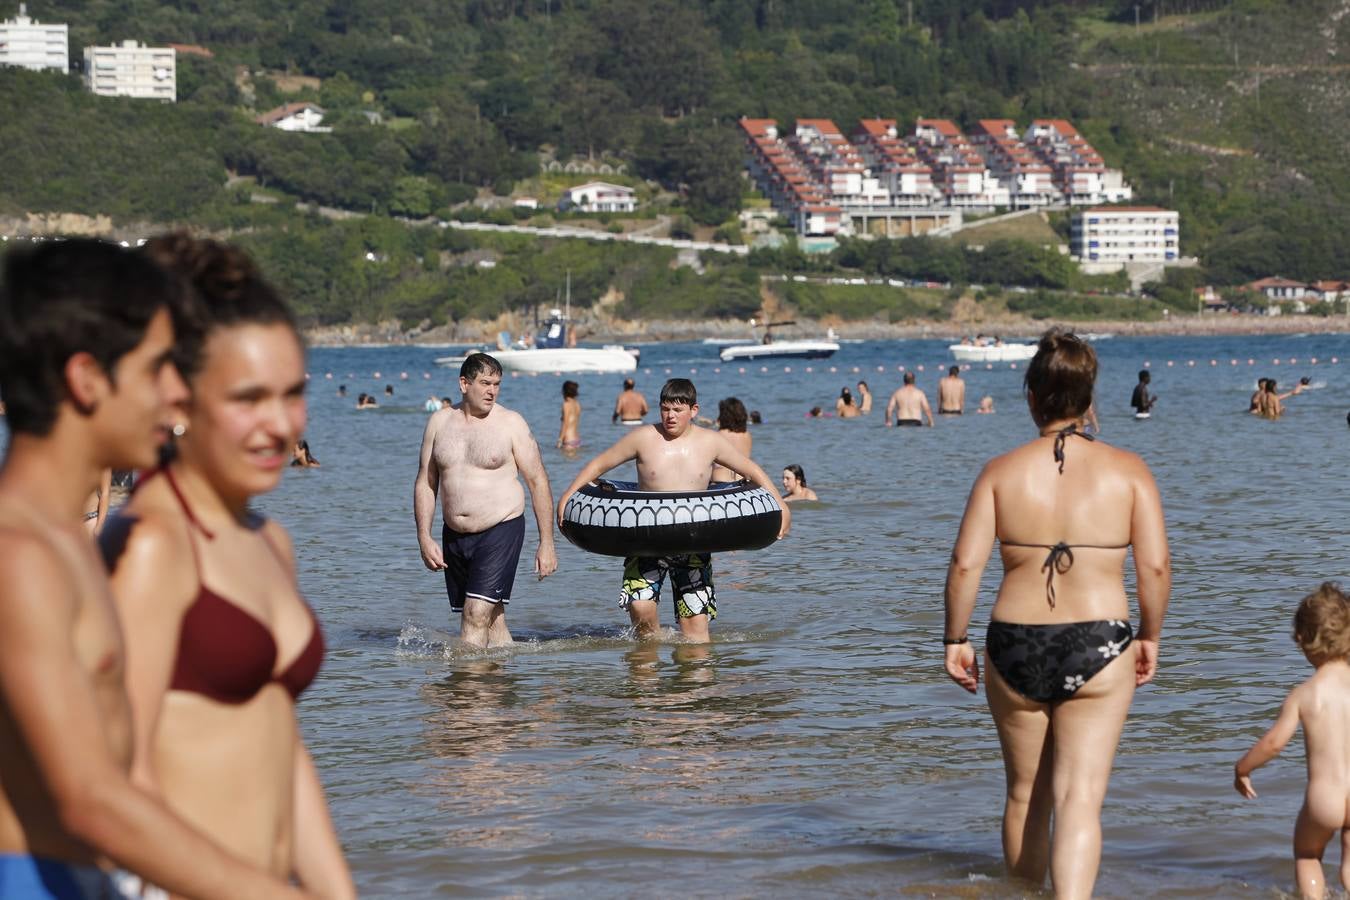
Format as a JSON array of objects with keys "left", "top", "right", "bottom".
[{"left": 21, "top": 335, "right": 1350, "bottom": 897}]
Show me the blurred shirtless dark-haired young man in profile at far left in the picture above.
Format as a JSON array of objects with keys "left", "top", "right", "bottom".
[{"left": 0, "top": 240, "right": 302, "bottom": 900}]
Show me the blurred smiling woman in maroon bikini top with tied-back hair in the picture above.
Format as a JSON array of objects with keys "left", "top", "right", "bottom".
[{"left": 107, "top": 235, "right": 355, "bottom": 897}]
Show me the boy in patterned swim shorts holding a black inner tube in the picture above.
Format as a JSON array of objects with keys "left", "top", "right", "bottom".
[{"left": 558, "top": 378, "right": 791, "bottom": 642}]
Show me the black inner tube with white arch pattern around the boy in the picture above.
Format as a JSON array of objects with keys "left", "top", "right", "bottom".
[{"left": 563, "top": 480, "right": 783, "bottom": 556}]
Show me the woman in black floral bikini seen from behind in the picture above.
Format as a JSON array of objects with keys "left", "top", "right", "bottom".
[{"left": 942, "top": 329, "right": 1172, "bottom": 897}]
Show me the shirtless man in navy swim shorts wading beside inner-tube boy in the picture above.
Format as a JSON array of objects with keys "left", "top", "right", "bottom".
[{"left": 413, "top": 354, "right": 558, "bottom": 646}]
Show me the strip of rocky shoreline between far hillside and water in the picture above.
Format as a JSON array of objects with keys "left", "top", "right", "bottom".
[{"left": 305, "top": 313, "right": 1350, "bottom": 347}]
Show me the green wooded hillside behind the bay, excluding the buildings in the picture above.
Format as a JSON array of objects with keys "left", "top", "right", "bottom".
[{"left": 0, "top": 0, "right": 1350, "bottom": 322}]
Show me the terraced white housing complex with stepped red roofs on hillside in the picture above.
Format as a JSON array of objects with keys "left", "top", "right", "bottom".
[{"left": 740, "top": 119, "right": 1133, "bottom": 236}]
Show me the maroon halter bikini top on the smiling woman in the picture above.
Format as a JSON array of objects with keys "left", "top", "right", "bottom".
[{"left": 147, "top": 468, "right": 324, "bottom": 703}]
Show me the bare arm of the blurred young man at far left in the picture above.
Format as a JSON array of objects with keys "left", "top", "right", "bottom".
[{"left": 0, "top": 540, "right": 306, "bottom": 900}]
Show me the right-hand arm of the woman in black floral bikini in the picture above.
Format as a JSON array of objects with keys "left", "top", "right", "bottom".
[{"left": 1130, "top": 457, "right": 1172, "bottom": 685}]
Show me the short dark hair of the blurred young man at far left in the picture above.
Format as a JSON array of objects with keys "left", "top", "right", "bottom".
[{"left": 0, "top": 239, "right": 184, "bottom": 437}]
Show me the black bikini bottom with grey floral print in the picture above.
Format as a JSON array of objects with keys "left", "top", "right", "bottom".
[{"left": 984, "top": 619, "right": 1134, "bottom": 703}]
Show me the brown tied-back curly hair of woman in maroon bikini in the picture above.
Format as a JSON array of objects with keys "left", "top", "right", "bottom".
[{"left": 144, "top": 231, "right": 300, "bottom": 382}]
